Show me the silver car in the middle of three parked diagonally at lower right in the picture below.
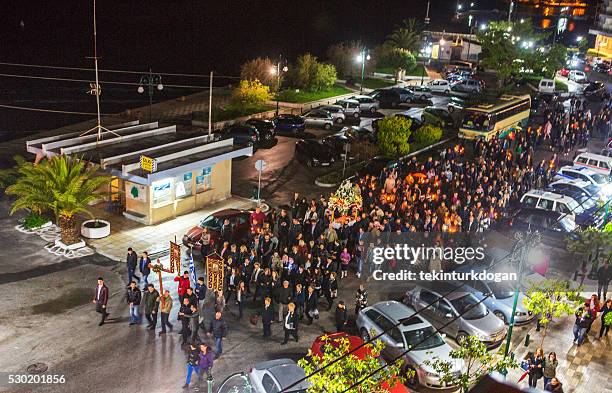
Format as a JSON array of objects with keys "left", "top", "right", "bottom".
[{"left": 404, "top": 285, "right": 506, "bottom": 348}]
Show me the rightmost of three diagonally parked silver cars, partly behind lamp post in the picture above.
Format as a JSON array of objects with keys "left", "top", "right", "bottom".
[{"left": 455, "top": 264, "right": 535, "bottom": 325}]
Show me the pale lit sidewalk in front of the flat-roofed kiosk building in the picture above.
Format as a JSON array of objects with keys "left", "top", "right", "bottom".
[{"left": 87, "top": 196, "right": 256, "bottom": 261}]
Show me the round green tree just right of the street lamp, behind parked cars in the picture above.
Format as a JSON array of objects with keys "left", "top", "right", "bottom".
[{"left": 289, "top": 53, "right": 337, "bottom": 91}]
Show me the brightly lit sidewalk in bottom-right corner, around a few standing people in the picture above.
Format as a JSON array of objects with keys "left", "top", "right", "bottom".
[{"left": 507, "top": 310, "right": 612, "bottom": 393}]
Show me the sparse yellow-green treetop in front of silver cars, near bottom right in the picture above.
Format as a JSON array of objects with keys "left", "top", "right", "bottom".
[{"left": 424, "top": 336, "right": 518, "bottom": 393}]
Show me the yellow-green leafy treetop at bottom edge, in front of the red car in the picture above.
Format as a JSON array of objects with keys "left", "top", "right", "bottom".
[{"left": 298, "top": 336, "right": 404, "bottom": 393}]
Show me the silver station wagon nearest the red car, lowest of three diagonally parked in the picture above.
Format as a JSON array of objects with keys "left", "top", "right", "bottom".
[{"left": 356, "top": 301, "right": 463, "bottom": 388}]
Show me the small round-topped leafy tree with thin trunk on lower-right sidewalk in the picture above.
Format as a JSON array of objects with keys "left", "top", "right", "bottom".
[{"left": 523, "top": 280, "right": 581, "bottom": 347}]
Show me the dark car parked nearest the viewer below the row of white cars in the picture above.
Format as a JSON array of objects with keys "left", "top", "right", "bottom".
[{"left": 498, "top": 208, "right": 576, "bottom": 245}]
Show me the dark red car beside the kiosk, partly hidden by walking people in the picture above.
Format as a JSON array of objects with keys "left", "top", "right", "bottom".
[{"left": 183, "top": 209, "right": 251, "bottom": 251}]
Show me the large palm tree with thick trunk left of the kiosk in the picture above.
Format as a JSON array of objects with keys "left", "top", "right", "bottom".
[{"left": 6, "top": 155, "right": 109, "bottom": 245}]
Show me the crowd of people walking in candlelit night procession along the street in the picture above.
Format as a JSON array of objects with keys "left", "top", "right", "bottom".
[{"left": 94, "top": 91, "right": 611, "bottom": 391}]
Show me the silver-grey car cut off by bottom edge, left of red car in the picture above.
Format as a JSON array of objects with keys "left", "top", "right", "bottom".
[{"left": 216, "top": 359, "right": 310, "bottom": 393}]
